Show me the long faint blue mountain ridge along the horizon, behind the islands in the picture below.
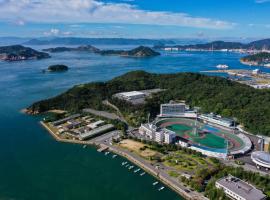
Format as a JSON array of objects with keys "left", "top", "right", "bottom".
[{"left": 24, "top": 37, "right": 175, "bottom": 45}]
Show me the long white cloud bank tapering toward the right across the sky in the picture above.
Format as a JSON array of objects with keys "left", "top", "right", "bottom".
[{"left": 0, "top": 0, "right": 235, "bottom": 29}]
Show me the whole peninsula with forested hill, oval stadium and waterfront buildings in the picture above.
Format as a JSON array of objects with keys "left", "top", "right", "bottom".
[{"left": 28, "top": 71, "right": 270, "bottom": 200}]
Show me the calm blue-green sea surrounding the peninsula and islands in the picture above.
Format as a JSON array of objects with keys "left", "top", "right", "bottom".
[{"left": 0, "top": 47, "right": 266, "bottom": 200}]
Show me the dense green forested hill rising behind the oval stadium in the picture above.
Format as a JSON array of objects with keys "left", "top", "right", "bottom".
[{"left": 27, "top": 71, "right": 270, "bottom": 136}]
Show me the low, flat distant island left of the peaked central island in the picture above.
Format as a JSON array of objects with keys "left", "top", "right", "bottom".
[{"left": 42, "top": 45, "right": 100, "bottom": 53}]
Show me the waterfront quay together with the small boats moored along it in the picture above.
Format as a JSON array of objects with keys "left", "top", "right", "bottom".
[{"left": 40, "top": 121, "right": 207, "bottom": 200}]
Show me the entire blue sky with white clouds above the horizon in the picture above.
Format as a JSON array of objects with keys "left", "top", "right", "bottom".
[{"left": 0, "top": 0, "right": 270, "bottom": 39}]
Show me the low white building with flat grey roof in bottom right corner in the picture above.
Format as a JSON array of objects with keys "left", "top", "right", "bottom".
[{"left": 215, "top": 175, "right": 266, "bottom": 200}]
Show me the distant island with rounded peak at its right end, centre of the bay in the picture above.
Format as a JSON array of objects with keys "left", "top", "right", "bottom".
[{"left": 99, "top": 46, "right": 160, "bottom": 57}]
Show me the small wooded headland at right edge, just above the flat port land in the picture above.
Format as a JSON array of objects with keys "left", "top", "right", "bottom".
[{"left": 240, "top": 52, "right": 270, "bottom": 67}]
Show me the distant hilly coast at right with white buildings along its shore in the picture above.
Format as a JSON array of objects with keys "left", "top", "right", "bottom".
[{"left": 154, "top": 39, "right": 270, "bottom": 51}]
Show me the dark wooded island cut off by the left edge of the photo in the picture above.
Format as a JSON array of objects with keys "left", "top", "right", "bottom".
[{"left": 0, "top": 45, "right": 50, "bottom": 61}]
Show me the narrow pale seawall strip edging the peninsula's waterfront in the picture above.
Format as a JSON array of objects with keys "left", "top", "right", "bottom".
[{"left": 40, "top": 121, "right": 208, "bottom": 200}]
